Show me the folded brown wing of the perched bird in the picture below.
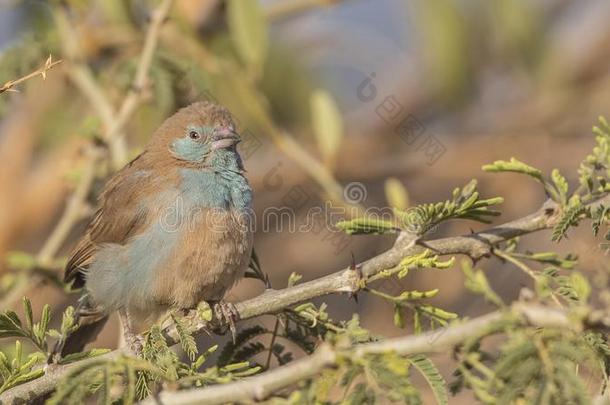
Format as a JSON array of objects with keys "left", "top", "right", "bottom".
[{"left": 64, "top": 154, "right": 150, "bottom": 288}]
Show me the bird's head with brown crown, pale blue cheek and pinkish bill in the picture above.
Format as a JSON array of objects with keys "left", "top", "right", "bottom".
[{"left": 149, "top": 102, "right": 243, "bottom": 170}]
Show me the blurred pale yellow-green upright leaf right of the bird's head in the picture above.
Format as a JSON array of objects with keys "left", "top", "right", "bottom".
[{"left": 309, "top": 89, "right": 343, "bottom": 168}]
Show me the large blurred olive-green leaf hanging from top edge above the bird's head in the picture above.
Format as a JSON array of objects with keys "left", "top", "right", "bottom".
[{"left": 227, "top": 0, "right": 268, "bottom": 77}]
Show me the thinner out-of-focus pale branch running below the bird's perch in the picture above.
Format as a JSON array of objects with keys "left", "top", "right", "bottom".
[{"left": 142, "top": 303, "right": 600, "bottom": 405}]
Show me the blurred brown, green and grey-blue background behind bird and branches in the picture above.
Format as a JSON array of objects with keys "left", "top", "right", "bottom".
[{"left": 0, "top": 0, "right": 610, "bottom": 403}]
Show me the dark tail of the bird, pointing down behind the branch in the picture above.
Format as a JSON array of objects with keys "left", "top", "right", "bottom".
[{"left": 49, "top": 296, "right": 108, "bottom": 362}]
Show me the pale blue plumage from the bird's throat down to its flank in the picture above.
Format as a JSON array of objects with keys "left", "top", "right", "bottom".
[{"left": 87, "top": 164, "right": 252, "bottom": 310}]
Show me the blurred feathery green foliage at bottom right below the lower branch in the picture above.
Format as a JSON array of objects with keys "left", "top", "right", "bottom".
[{"left": 452, "top": 329, "right": 599, "bottom": 404}]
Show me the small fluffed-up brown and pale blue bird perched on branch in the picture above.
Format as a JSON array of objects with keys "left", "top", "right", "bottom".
[{"left": 56, "top": 102, "right": 253, "bottom": 355}]
